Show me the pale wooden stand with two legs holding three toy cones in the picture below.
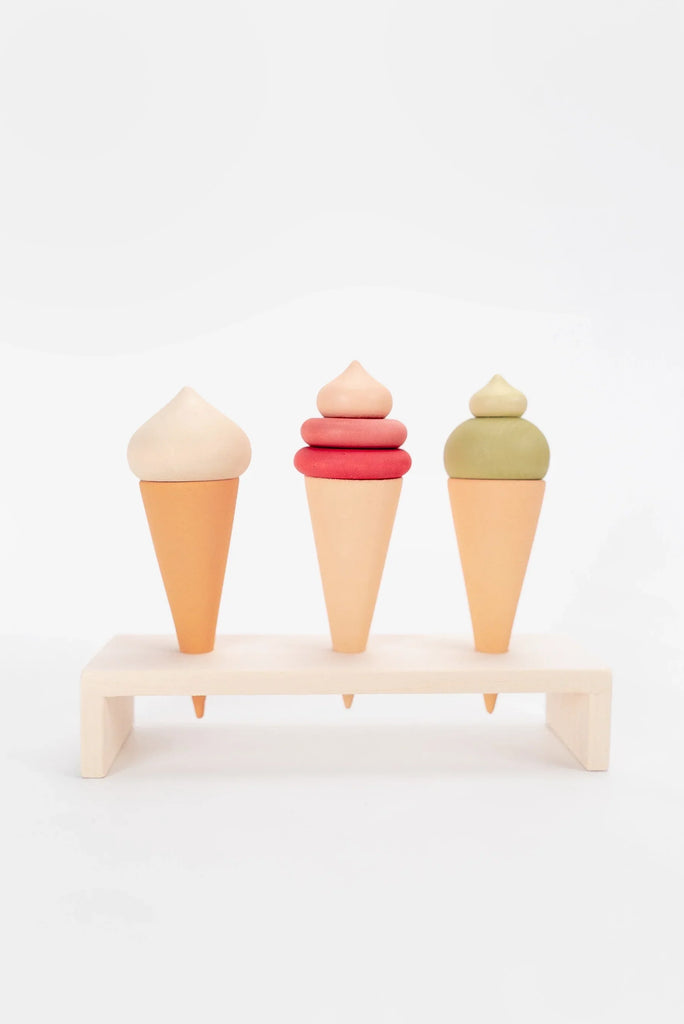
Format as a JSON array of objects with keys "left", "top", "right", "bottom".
[{"left": 81, "top": 636, "right": 611, "bottom": 778}]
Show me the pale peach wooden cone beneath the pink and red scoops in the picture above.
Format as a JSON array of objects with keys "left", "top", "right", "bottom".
[{"left": 306, "top": 476, "right": 401, "bottom": 651}]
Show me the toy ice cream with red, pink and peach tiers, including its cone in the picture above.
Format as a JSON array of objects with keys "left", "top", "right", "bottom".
[{"left": 295, "top": 361, "right": 411, "bottom": 708}]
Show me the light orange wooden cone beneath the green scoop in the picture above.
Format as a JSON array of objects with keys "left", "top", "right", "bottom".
[{"left": 448, "top": 479, "right": 546, "bottom": 655}]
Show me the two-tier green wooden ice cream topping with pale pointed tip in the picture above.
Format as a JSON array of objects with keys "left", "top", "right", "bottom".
[{"left": 444, "top": 375, "right": 550, "bottom": 480}]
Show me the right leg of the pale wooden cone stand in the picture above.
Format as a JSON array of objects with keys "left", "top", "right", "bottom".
[{"left": 546, "top": 691, "right": 610, "bottom": 771}]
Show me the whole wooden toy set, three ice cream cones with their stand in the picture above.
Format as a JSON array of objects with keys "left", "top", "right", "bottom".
[{"left": 81, "top": 362, "right": 611, "bottom": 778}]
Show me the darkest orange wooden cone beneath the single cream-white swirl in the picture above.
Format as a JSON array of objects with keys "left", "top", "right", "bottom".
[{"left": 140, "top": 477, "right": 240, "bottom": 718}]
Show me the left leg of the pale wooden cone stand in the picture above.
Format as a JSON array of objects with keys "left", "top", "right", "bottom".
[{"left": 81, "top": 689, "right": 133, "bottom": 778}]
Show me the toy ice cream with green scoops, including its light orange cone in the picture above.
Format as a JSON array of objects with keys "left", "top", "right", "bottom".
[{"left": 444, "top": 376, "right": 549, "bottom": 713}]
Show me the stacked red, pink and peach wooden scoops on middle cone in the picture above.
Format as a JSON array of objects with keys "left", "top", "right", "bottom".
[{"left": 295, "top": 361, "right": 411, "bottom": 480}]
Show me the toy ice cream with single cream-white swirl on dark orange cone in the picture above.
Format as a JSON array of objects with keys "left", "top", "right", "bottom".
[{"left": 128, "top": 387, "right": 252, "bottom": 718}]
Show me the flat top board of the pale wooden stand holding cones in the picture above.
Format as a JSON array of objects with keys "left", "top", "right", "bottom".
[{"left": 82, "top": 634, "right": 611, "bottom": 695}]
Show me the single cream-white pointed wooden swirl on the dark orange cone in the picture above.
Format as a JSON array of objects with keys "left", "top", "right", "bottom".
[{"left": 128, "top": 387, "right": 252, "bottom": 481}]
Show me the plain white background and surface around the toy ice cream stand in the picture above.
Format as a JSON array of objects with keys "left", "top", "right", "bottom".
[{"left": 0, "top": 0, "right": 684, "bottom": 1024}]
